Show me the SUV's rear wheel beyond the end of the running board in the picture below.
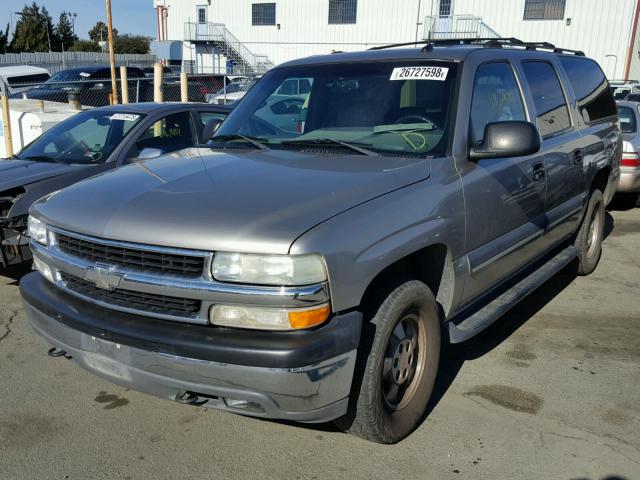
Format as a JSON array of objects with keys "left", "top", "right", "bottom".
[{"left": 574, "top": 190, "right": 605, "bottom": 275}]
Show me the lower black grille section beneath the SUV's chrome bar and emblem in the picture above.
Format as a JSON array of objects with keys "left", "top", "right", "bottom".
[{"left": 60, "top": 272, "right": 202, "bottom": 318}]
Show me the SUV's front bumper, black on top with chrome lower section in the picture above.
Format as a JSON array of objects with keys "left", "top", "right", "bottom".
[{"left": 20, "top": 273, "right": 362, "bottom": 422}]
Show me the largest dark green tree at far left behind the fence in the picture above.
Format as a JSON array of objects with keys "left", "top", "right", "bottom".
[{"left": 9, "top": 2, "right": 60, "bottom": 52}]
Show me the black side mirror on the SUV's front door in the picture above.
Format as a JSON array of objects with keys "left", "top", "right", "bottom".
[{"left": 469, "top": 121, "right": 540, "bottom": 161}]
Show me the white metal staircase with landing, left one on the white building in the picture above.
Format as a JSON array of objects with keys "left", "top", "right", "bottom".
[{"left": 184, "top": 22, "right": 275, "bottom": 75}]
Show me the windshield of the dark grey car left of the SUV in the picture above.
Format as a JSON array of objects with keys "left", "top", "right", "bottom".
[{"left": 16, "top": 110, "right": 142, "bottom": 165}]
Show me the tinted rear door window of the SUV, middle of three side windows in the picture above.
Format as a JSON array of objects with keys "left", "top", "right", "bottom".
[{"left": 522, "top": 61, "right": 571, "bottom": 138}]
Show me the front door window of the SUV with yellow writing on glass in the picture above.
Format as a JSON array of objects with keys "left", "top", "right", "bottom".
[{"left": 470, "top": 62, "right": 526, "bottom": 143}]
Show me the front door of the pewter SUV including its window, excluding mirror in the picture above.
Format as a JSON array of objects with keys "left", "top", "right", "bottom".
[{"left": 460, "top": 60, "right": 546, "bottom": 303}]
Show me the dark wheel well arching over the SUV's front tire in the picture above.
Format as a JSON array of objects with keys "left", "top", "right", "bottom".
[{"left": 361, "top": 244, "right": 454, "bottom": 315}]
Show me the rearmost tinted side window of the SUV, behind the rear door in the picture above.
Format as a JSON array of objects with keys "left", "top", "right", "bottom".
[{"left": 560, "top": 57, "right": 616, "bottom": 122}]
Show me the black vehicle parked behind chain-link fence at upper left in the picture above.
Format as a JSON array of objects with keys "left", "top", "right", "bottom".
[{"left": 21, "top": 66, "right": 148, "bottom": 107}]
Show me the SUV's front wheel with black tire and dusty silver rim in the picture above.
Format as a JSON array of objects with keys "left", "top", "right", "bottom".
[{"left": 336, "top": 280, "right": 440, "bottom": 443}]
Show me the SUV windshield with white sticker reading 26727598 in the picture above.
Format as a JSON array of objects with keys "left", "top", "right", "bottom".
[{"left": 218, "top": 60, "right": 456, "bottom": 156}]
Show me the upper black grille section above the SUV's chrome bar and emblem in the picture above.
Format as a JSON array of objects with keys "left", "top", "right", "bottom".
[{"left": 56, "top": 234, "right": 205, "bottom": 278}]
